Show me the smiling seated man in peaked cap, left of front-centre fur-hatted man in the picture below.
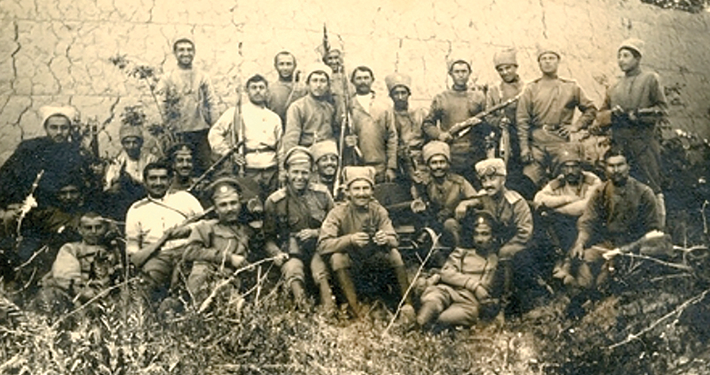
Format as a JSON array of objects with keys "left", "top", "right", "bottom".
[{"left": 264, "top": 147, "right": 335, "bottom": 313}]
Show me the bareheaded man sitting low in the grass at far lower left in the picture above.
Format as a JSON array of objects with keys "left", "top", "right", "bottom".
[{"left": 33, "top": 212, "right": 122, "bottom": 314}]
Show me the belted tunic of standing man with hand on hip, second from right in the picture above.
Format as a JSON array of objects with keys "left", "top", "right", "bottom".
[{"left": 516, "top": 77, "right": 596, "bottom": 150}]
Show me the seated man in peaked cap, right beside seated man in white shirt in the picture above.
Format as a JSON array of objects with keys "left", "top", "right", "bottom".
[{"left": 182, "top": 177, "right": 266, "bottom": 303}]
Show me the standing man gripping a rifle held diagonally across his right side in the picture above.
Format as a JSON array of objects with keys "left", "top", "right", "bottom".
[{"left": 422, "top": 59, "right": 486, "bottom": 185}]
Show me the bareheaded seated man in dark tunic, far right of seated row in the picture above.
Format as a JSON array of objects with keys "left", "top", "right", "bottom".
[{"left": 560, "top": 146, "right": 663, "bottom": 288}]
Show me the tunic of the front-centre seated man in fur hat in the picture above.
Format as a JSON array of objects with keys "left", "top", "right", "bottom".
[{"left": 317, "top": 199, "right": 397, "bottom": 255}]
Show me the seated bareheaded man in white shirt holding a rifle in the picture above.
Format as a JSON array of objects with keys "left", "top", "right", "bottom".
[{"left": 126, "top": 163, "right": 204, "bottom": 298}]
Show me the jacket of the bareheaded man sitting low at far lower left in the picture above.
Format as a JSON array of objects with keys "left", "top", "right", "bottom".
[{"left": 43, "top": 242, "right": 121, "bottom": 293}]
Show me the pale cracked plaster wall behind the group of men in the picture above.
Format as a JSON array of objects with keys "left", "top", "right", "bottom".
[{"left": 0, "top": 0, "right": 710, "bottom": 163}]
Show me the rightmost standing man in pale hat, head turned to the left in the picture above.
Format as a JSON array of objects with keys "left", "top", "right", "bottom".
[{"left": 599, "top": 39, "right": 668, "bottom": 224}]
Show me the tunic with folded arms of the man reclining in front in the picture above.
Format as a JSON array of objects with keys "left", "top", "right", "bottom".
[{"left": 441, "top": 247, "right": 498, "bottom": 300}]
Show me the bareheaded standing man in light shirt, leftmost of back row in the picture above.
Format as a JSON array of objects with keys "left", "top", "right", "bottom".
[{"left": 155, "top": 38, "right": 217, "bottom": 172}]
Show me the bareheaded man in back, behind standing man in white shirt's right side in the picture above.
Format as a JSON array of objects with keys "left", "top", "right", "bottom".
[{"left": 268, "top": 51, "right": 307, "bottom": 127}]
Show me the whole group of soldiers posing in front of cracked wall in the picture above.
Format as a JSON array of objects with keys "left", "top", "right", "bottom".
[{"left": 0, "top": 34, "right": 666, "bottom": 327}]
